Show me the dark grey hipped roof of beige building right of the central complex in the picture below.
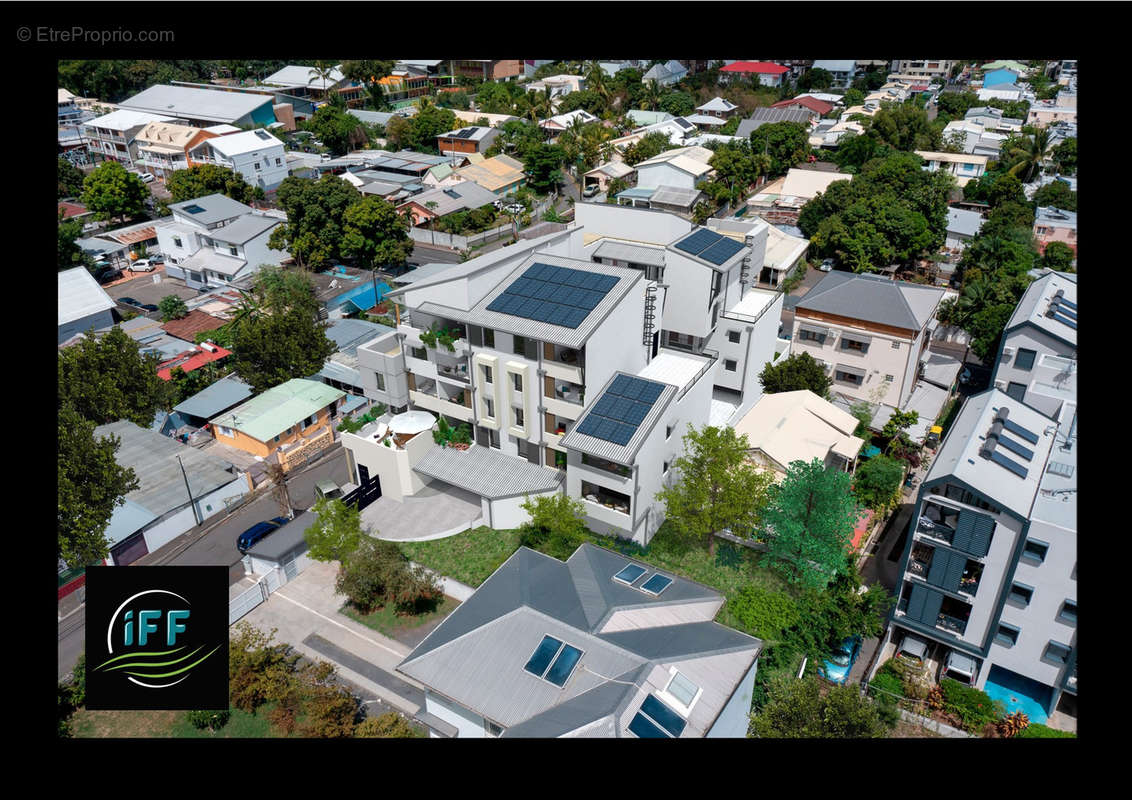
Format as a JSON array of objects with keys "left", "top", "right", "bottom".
[{"left": 795, "top": 272, "right": 944, "bottom": 330}]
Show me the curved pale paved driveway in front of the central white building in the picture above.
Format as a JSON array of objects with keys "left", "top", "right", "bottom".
[{"left": 361, "top": 481, "right": 482, "bottom": 542}]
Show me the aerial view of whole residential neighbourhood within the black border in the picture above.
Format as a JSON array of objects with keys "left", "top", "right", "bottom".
[{"left": 57, "top": 57, "right": 1078, "bottom": 739}]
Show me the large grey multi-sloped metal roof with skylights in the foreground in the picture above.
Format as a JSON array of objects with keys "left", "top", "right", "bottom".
[{"left": 397, "top": 543, "right": 762, "bottom": 737}]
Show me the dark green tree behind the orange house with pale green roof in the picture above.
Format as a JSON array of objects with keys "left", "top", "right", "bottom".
[{"left": 232, "top": 309, "right": 337, "bottom": 394}]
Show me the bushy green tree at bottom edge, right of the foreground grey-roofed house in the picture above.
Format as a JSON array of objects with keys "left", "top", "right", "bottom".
[{"left": 751, "top": 677, "right": 886, "bottom": 739}]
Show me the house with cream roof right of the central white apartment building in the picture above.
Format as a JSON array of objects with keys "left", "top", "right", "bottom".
[{"left": 735, "top": 389, "right": 865, "bottom": 480}]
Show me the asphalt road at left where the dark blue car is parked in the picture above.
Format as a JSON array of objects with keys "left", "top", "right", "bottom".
[{"left": 59, "top": 447, "right": 351, "bottom": 679}]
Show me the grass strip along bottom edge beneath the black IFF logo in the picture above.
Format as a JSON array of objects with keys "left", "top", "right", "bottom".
[{"left": 71, "top": 705, "right": 275, "bottom": 739}]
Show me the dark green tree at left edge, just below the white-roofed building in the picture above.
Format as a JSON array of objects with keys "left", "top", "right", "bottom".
[{"left": 58, "top": 326, "right": 169, "bottom": 428}]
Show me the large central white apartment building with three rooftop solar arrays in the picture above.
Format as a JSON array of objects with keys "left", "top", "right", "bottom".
[{"left": 343, "top": 204, "right": 782, "bottom": 544}]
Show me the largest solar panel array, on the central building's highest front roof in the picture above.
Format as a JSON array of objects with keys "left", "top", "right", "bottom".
[{"left": 487, "top": 264, "right": 619, "bottom": 328}]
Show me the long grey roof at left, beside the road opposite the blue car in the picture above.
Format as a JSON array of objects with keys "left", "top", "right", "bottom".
[{"left": 94, "top": 420, "right": 242, "bottom": 516}]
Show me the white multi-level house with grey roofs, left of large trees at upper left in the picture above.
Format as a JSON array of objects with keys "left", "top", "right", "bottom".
[{"left": 154, "top": 195, "right": 288, "bottom": 289}]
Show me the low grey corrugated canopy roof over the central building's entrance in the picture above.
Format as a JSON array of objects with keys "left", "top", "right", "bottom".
[{"left": 413, "top": 445, "right": 565, "bottom": 500}]
